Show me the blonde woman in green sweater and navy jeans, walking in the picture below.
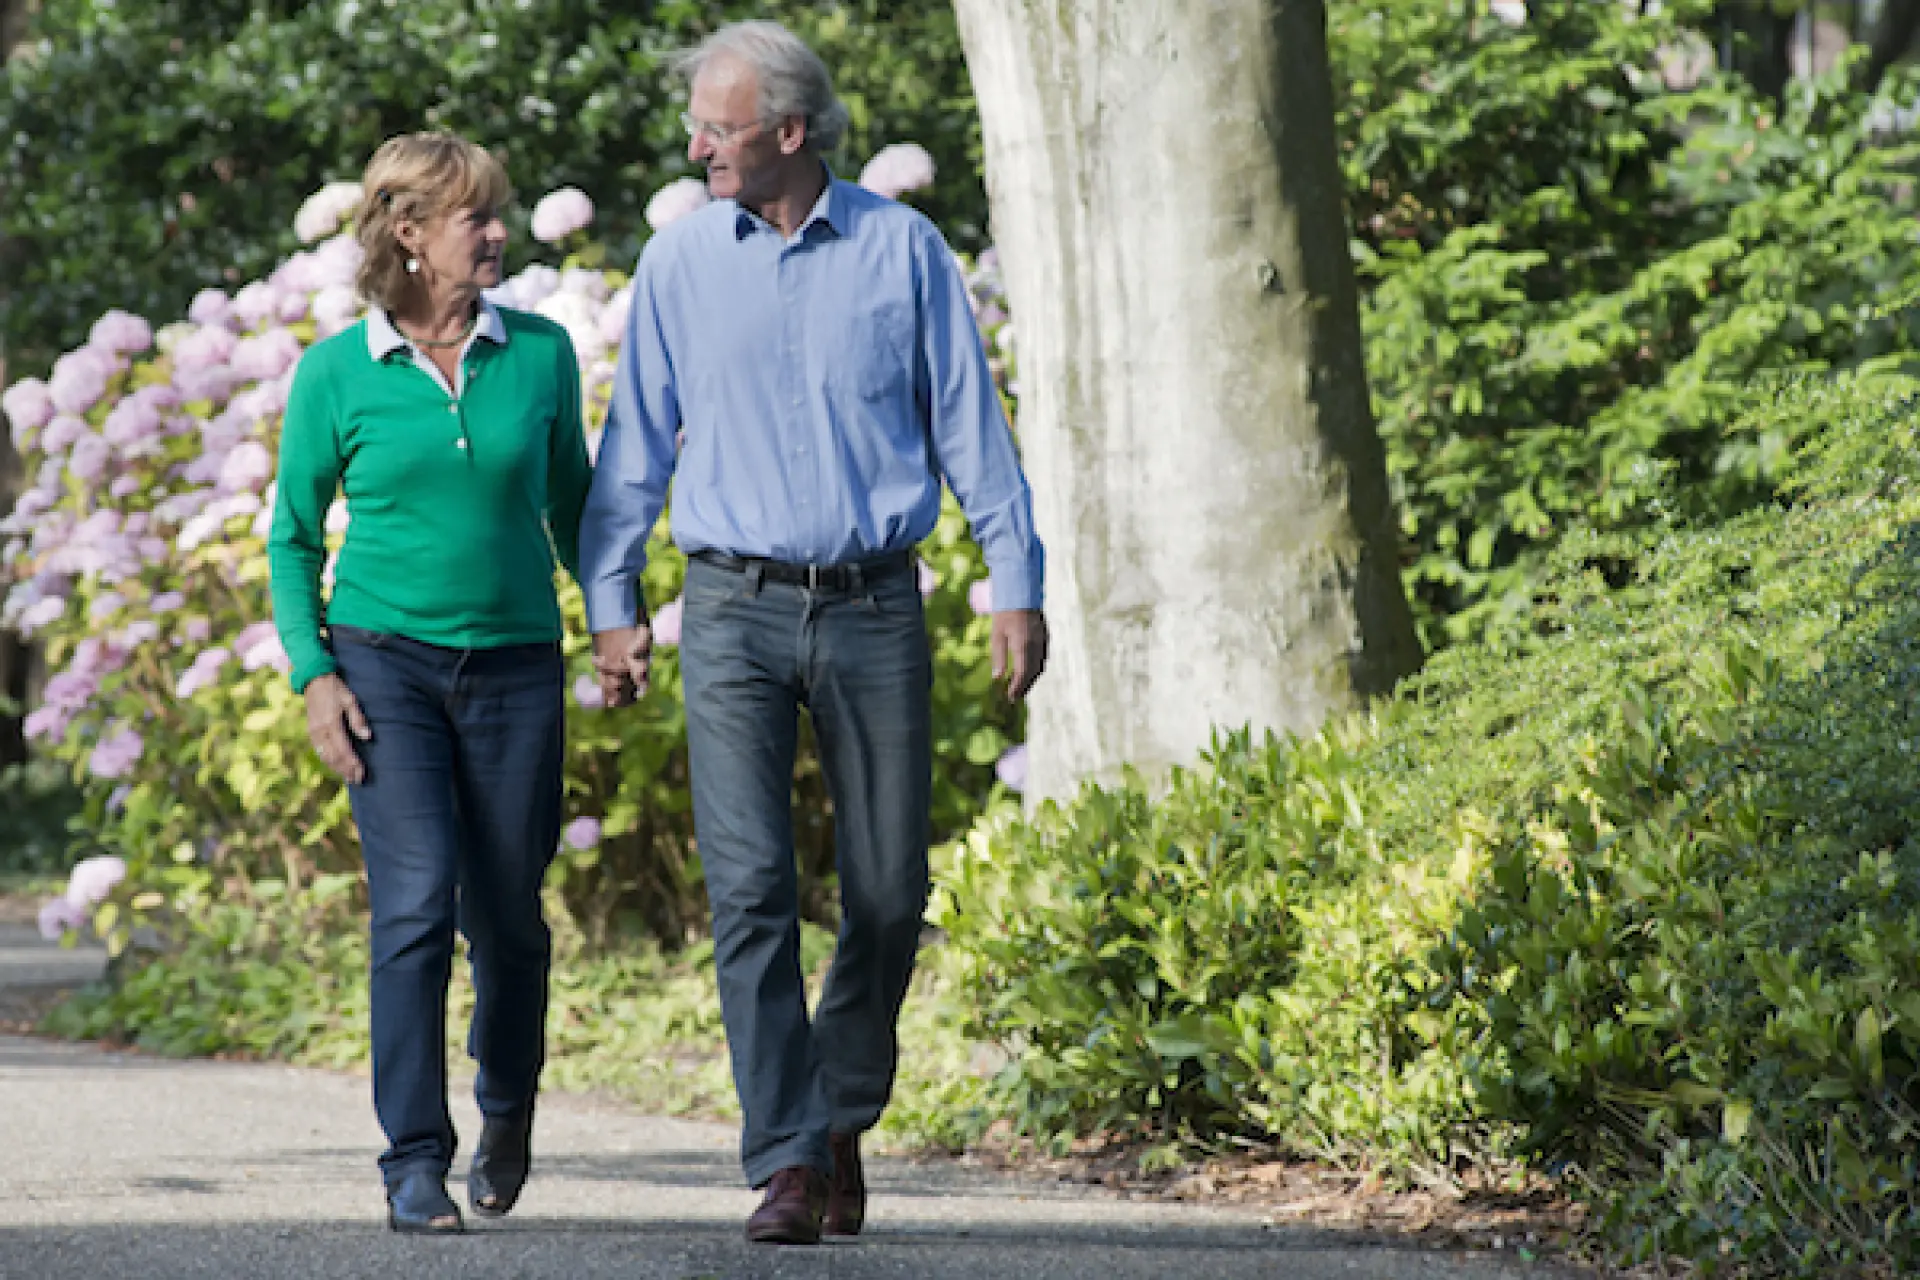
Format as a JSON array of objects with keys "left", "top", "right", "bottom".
[{"left": 269, "top": 132, "right": 589, "bottom": 1232}]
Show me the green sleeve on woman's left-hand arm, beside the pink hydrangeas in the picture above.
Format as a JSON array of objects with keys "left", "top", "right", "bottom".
[{"left": 267, "top": 347, "right": 342, "bottom": 693}]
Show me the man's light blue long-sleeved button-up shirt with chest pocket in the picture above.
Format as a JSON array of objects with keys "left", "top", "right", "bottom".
[{"left": 580, "top": 175, "right": 1044, "bottom": 631}]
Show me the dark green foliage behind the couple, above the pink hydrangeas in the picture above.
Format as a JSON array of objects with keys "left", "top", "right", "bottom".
[{"left": 0, "top": 0, "right": 985, "bottom": 374}]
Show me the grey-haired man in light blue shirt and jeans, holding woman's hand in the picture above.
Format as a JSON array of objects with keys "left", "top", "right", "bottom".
[{"left": 582, "top": 21, "right": 1046, "bottom": 1244}]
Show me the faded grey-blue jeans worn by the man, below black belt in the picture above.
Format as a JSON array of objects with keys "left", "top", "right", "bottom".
[{"left": 680, "top": 560, "right": 933, "bottom": 1186}]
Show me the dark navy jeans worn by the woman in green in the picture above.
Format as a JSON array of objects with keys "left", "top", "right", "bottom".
[{"left": 332, "top": 628, "right": 564, "bottom": 1186}]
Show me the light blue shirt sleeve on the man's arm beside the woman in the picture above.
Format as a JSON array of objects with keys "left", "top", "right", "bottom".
[{"left": 580, "top": 240, "right": 680, "bottom": 633}]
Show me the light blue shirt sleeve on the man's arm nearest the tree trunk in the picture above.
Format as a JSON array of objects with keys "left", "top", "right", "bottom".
[{"left": 914, "top": 225, "right": 1046, "bottom": 610}]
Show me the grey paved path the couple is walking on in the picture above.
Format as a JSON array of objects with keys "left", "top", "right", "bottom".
[{"left": 0, "top": 929, "right": 1559, "bottom": 1280}]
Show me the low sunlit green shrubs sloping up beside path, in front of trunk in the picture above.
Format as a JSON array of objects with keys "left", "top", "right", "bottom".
[{"left": 935, "top": 362, "right": 1920, "bottom": 1274}]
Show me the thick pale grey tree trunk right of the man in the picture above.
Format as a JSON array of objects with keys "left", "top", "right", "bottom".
[{"left": 956, "top": 0, "right": 1419, "bottom": 796}]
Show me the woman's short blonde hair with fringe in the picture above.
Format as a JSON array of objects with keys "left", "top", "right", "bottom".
[{"left": 355, "top": 132, "right": 513, "bottom": 311}]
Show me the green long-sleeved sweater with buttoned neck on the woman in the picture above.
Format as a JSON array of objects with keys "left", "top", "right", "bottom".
[{"left": 267, "top": 309, "right": 591, "bottom": 691}]
